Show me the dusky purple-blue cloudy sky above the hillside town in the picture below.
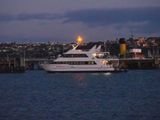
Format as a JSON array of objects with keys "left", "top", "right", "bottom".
[{"left": 0, "top": 0, "right": 160, "bottom": 42}]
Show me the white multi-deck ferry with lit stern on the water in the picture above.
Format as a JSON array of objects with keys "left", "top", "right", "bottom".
[{"left": 41, "top": 45, "right": 123, "bottom": 73}]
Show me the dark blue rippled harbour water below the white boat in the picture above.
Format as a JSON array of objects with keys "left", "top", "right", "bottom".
[{"left": 0, "top": 70, "right": 160, "bottom": 120}]
